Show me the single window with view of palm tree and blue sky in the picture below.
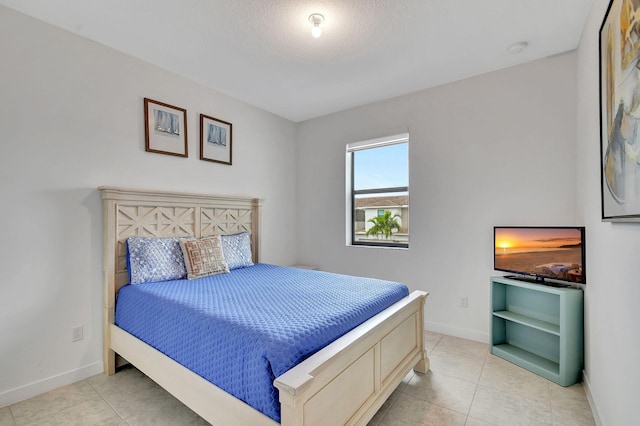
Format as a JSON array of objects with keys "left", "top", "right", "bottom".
[{"left": 347, "top": 134, "right": 409, "bottom": 248}]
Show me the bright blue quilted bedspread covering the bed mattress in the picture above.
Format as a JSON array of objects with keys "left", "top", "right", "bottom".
[{"left": 115, "top": 264, "right": 409, "bottom": 422}]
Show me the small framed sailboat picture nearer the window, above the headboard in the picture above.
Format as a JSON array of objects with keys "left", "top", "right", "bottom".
[{"left": 200, "top": 114, "right": 233, "bottom": 165}]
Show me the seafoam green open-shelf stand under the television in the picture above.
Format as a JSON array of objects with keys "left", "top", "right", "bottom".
[{"left": 490, "top": 277, "right": 583, "bottom": 386}]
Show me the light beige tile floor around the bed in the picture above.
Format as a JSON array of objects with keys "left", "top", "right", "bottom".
[{"left": 0, "top": 332, "right": 595, "bottom": 426}]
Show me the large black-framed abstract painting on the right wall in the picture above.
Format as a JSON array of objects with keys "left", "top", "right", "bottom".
[{"left": 600, "top": 0, "right": 640, "bottom": 222}]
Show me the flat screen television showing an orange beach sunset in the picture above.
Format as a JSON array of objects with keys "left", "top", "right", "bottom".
[{"left": 493, "top": 226, "right": 587, "bottom": 285}]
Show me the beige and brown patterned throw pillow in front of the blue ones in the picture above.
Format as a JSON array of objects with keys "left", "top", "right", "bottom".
[{"left": 180, "top": 235, "right": 229, "bottom": 280}]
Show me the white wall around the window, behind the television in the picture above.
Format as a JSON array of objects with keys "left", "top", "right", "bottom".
[{"left": 298, "top": 53, "right": 580, "bottom": 341}]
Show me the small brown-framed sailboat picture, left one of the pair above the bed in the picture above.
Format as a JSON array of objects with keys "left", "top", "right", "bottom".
[{"left": 144, "top": 98, "right": 189, "bottom": 157}]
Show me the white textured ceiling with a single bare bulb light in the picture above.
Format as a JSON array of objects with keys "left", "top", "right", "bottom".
[{"left": 0, "top": 0, "right": 592, "bottom": 122}]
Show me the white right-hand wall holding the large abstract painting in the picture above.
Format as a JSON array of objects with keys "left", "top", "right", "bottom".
[{"left": 576, "top": 0, "right": 640, "bottom": 426}]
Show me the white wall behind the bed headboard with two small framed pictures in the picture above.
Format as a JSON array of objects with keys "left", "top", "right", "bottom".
[{"left": 0, "top": 6, "right": 297, "bottom": 407}]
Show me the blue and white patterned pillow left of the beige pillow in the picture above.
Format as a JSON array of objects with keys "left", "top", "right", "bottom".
[{"left": 127, "top": 236, "right": 192, "bottom": 284}]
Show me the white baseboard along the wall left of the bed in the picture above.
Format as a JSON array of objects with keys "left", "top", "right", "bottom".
[{"left": 0, "top": 362, "right": 103, "bottom": 408}]
